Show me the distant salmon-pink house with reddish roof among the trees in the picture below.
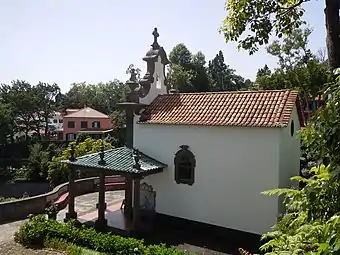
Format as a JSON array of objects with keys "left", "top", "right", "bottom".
[{"left": 63, "top": 107, "right": 112, "bottom": 141}]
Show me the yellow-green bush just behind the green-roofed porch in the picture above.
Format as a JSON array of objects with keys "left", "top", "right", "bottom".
[{"left": 47, "top": 138, "right": 112, "bottom": 187}]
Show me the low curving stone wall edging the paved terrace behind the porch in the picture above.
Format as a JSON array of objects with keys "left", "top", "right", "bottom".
[{"left": 0, "top": 176, "right": 125, "bottom": 224}]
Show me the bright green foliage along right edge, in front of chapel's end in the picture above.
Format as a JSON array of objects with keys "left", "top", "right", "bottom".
[{"left": 261, "top": 70, "right": 340, "bottom": 255}]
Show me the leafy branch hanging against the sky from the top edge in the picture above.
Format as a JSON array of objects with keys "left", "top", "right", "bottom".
[{"left": 221, "top": 0, "right": 307, "bottom": 54}]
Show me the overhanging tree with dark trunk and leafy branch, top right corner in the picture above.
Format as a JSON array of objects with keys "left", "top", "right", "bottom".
[{"left": 221, "top": 0, "right": 340, "bottom": 69}]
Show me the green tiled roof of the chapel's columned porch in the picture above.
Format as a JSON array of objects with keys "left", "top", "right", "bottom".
[{"left": 65, "top": 147, "right": 167, "bottom": 174}]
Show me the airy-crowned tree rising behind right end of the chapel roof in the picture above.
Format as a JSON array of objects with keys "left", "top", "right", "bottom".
[{"left": 256, "top": 27, "right": 328, "bottom": 99}]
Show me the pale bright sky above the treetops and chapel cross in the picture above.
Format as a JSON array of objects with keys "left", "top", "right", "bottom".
[{"left": 0, "top": 0, "right": 325, "bottom": 92}]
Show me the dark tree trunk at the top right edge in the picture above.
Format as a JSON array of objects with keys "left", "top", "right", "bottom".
[{"left": 325, "top": 0, "right": 340, "bottom": 70}]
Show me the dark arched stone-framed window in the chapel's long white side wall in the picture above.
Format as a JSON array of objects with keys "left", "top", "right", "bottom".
[{"left": 174, "top": 145, "right": 196, "bottom": 185}]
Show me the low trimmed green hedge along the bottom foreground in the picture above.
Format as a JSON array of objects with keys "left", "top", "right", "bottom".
[{"left": 14, "top": 215, "right": 188, "bottom": 255}]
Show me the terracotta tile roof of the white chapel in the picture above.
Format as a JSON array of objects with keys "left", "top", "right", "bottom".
[{"left": 139, "top": 90, "right": 304, "bottom": 127}]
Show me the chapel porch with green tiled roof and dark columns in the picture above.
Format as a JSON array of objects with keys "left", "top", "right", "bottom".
[{"left": 64, "top": 144, "right": 166, "bottom": 230}]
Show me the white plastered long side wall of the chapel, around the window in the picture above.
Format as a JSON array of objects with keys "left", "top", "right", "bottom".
[{"left": 134, "top": 121, "right": 280, "bottom": 234}]
